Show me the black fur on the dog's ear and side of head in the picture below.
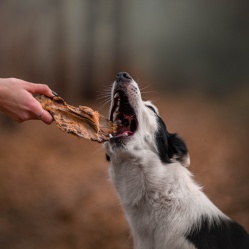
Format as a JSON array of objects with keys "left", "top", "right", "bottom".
[{"left": 156, "top": 115, "right": 188, "bottom": 163}]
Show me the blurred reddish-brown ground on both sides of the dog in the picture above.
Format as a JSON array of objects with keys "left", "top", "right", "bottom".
[{"left": 0, "top": 93, "right": 249, "bottom": 249}]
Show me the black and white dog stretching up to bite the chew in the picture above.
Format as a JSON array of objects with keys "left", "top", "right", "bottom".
[{"left": 104, "top": 73, "right": 249, "bottom": 249}]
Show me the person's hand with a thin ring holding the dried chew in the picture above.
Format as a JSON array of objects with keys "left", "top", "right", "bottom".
[{"left": 0, "top": 78, "right": 54, "bottom": 124}]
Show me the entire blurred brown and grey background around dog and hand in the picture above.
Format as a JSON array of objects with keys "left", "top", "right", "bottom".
[{"left": 0, "top": 0, "right": 249, "bottom": 249}]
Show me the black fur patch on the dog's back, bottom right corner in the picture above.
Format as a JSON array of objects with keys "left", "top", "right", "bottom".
[{"left": 186, "top": 217, "right": 249, "bottom": 249}]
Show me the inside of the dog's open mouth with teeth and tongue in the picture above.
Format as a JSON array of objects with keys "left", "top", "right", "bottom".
[{"left": 110, "top": 90, "right": 138, "bottom": 138}]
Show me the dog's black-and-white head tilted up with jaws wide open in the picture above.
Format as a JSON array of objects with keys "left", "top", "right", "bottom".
[{"left": 104, "top": 72, "right": 189, "bottom": 166}]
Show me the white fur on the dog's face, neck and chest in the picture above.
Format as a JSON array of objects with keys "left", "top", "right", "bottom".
[{"left": 104, "top": 81, "right": 229, "bottom": 249}]
